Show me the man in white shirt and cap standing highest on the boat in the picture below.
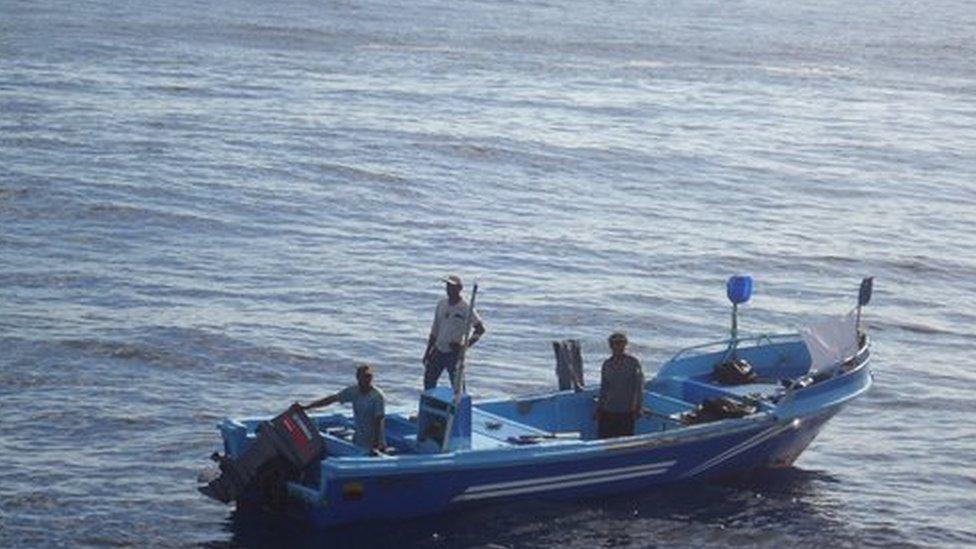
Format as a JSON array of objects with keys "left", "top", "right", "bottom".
[{"left": 423, "top": 275, "right": 485, "bottom": 391}]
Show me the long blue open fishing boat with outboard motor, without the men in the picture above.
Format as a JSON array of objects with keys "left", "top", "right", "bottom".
[{"left": 203, "top": 277, "right": 872, "bottom": 526}]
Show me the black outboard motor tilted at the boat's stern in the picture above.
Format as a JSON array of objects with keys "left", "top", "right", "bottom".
[{"left": 199, "top": 404, "right": 325, "bottom": 503}]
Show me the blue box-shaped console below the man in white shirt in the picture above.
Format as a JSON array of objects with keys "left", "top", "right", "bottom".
[{"left": 417, "top": 387, "right": 471, "bottom": 454}]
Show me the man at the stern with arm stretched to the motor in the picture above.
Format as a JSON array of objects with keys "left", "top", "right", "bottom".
[{"left": 302, "top": 364, "right": 386, "bottom": 452}]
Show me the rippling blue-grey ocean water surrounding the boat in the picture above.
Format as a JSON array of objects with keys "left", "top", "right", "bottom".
[{"left": 0, "top": 0, "right": 976, "bottom": 548}]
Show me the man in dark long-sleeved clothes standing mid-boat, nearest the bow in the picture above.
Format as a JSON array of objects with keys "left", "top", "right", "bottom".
[{"left": 594, "top": 332, "right": 644, "bottom": 438}]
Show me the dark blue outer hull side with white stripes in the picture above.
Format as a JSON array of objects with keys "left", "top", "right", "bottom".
[{"left": 312, "top": 407, "right": 860, "bottom": 527}]
